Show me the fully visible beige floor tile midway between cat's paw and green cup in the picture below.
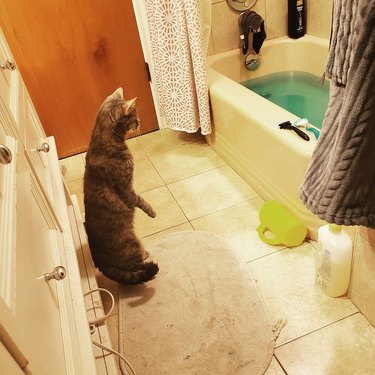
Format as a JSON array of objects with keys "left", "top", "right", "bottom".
[{"left": 168, "top": 166, "right": 257, "bottom": 220}]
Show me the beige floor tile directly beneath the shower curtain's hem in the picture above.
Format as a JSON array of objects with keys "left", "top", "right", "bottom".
[{"left": 138, "top": 129, "right": 205, "bottom": 155}]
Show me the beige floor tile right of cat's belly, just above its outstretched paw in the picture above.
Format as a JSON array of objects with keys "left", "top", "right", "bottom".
[{"left": 134, "top": 158, "right": 164, "bottom": 194}]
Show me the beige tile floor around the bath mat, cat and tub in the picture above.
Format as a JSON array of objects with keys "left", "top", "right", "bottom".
[{"left": 61, "top": 130, "right": 375, "bottom": 375}]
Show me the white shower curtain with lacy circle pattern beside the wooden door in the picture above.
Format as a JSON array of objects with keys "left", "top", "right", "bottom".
[{"left": 146, "top": 0, "right": 211, "bottom": 135}]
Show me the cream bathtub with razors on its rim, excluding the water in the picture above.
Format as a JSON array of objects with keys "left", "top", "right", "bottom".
[{"left": 207, "top": 35, "right": 328, "bottom": 239}]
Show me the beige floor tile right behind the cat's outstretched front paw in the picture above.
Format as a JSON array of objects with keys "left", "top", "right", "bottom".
[{"left": 135, "top": 186, "right": 187, "bottom": 237}]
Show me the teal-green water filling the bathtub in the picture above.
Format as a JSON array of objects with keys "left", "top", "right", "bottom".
[{"left": 241, "top": 71, "right": 329, "bottom": 128}]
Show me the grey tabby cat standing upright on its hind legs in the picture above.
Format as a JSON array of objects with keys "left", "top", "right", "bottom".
[{"left": 84, "top": 88, "right": 159, "bottom": 284}]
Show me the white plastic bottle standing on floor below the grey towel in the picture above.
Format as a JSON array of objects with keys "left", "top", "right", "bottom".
[{"left": 315, "top": 224, "right": 353, "bottom": 297}]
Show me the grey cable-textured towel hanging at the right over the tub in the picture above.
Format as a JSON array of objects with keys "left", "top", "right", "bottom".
[{"left": 299, "top": 0, "right": 375, "bottom": 228}]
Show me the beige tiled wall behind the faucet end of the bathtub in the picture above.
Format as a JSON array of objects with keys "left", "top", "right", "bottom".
[{"left": 208, "top": 0, "right": 333, "bottom": 55}]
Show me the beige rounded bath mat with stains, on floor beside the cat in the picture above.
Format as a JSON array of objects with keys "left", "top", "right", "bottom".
[{"left": 119, "top": 232, "right": 274, "bottom": 375}]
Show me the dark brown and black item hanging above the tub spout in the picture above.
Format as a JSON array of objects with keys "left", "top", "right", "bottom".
[{"left": 238, "top": 10, "right": 267, "bottom": 55}]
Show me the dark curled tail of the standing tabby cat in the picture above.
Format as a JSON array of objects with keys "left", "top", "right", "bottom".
[{"left": 99, "top": 262, "right": 159, "bottom": 284}]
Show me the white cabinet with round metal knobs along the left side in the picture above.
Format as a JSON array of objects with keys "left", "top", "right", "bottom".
[{"left": 0, "top": 30, "right": 96, "bottom": 375}]
